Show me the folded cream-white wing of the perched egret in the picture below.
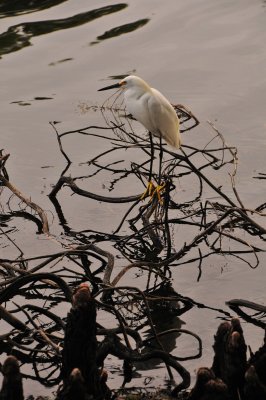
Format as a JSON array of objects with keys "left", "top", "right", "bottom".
[{"left": 148, "top": 89, "right": 180, "bottom": 148}]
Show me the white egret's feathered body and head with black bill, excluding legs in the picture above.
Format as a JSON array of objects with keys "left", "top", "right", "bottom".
[{"left": 99, "top": 75, "right": 181, "bottom": 149}]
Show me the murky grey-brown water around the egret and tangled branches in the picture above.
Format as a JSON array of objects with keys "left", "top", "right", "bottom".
[{"left": 0, "top": 0, "right": 266, "bottom": 394}]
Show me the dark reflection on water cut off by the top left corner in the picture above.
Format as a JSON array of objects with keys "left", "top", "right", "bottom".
[{"left": 0, "top": 0, "right": 66, "bottom": 18}]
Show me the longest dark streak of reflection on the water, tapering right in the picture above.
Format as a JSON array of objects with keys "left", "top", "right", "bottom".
[{"left": 0, "top": 3, "right": 127, "bottom": 56}]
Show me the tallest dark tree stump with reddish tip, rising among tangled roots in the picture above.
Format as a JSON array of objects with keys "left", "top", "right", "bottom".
[{"left": 57, "top": 284, "right": 107, "bottom": 400}]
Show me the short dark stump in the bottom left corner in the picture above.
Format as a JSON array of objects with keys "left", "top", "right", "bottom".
[{"left": 0, "top": 356, "right": 24, "bottom": 400}]
